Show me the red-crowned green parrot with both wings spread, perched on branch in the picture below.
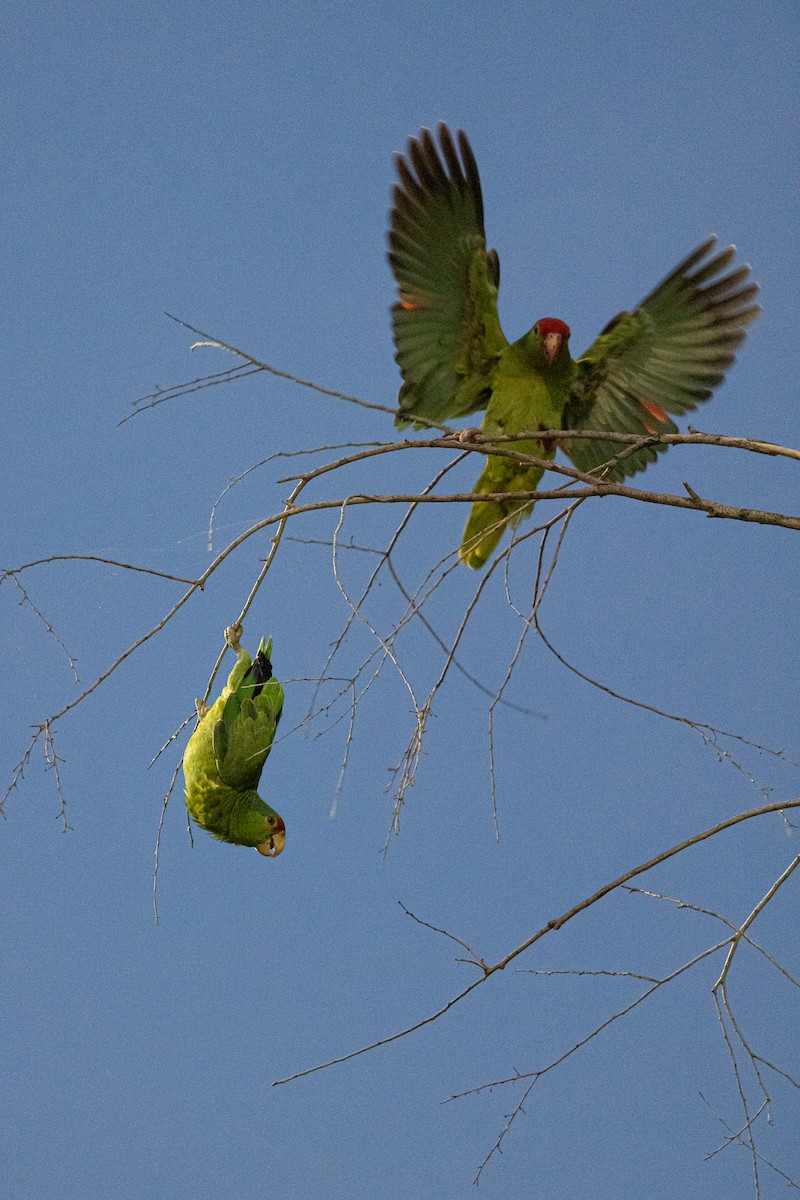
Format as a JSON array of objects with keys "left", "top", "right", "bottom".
[{"left": 389, "top": 124, "right": 760, "bottom": 568}]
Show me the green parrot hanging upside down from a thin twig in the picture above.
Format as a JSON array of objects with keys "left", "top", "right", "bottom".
[{"left": 184, "top": 625, "right": 287, "bottom": 858}]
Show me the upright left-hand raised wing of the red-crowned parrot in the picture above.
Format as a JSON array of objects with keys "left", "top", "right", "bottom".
[{"left": 389, "top": 124, "right": 509, "bottom": 428}]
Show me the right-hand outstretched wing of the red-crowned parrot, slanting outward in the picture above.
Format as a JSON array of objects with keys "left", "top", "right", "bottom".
[{"left": 563, "top": 238, "right": 760, "bottom": 480}]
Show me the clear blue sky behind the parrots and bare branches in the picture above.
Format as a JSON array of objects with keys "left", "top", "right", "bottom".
[{"left": 0, "top": 0, "right": 800, "bottom": 1200}]
